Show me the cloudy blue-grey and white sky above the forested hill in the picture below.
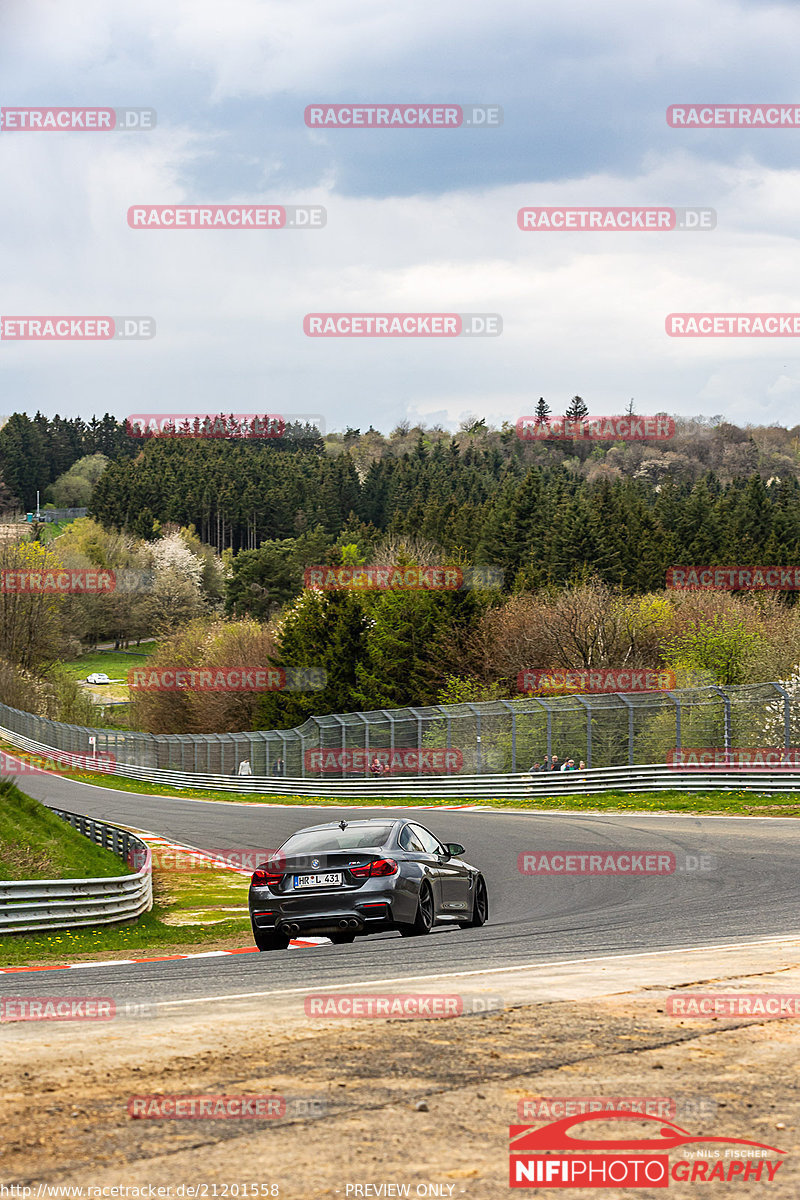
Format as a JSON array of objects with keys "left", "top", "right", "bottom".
[{"left": 0, "top": 0, "right": 800, "bottom": 431}]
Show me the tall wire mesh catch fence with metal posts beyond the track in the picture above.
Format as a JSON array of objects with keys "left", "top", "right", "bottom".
[{"left": 0, "top": 683, "right": 800, "bottom": 781}]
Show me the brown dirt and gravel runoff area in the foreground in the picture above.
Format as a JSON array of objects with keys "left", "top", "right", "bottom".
[{"left": 0, "top": 940, "right": 800, "bottom": 1200}]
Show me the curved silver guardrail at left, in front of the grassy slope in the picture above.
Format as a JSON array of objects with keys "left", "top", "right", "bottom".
[{"left": 0, "top": 809, "right": 152, "bottom": 934}]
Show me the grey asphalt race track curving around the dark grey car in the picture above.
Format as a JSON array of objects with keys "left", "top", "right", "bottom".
[{"left": 2, "top": 776, "right": 800, "bottom": 1003}]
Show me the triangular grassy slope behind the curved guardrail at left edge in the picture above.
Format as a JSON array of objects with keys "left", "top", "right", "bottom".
[{"left": 0, "top": 780, "right": 128, "bottom": 880}]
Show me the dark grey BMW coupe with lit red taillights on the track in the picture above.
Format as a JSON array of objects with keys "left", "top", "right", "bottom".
[{"left": 249, "top": 817, "right": 489, "bottom": 950}]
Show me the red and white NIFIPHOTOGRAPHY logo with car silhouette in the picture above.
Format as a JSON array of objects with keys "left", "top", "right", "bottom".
[{"left": 509, "top": 1110, "right": 786, "bottom": 1189}]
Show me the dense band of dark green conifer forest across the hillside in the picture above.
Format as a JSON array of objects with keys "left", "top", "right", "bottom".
[{"left": 90, "top": 442, "right": 800, "bottom": 595}]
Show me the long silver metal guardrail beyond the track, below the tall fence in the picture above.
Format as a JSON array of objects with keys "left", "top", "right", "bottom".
[{"left": 0, "top": 710, "right": 800, "bottom": 796}]
